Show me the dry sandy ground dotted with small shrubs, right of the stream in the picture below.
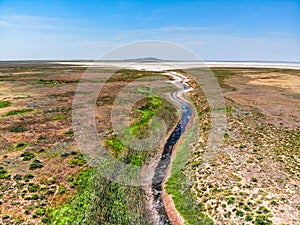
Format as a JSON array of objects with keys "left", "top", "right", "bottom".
[{"left": 193, "top": 69, "right": 300, "bottom": 225}]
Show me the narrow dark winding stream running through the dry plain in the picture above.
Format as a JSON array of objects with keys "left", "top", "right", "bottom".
[{"left": 151, "top": 77, "right": 192, "bottom": 225}]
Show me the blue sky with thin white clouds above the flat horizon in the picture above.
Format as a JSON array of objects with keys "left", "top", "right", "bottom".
[{"left": 0, "top": 0, "right": 300, "bottom": 62}]
